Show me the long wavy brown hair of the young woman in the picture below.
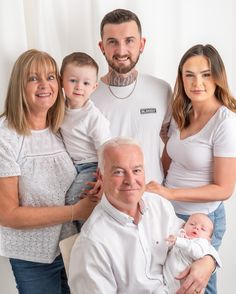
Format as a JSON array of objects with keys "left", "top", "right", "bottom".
[{"left": 172, "top": 44, "right": 236, "bottom": 130}]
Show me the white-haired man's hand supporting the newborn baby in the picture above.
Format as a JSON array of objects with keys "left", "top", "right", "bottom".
[{"left": 176, "top": 255, "right": 215, "bottom": 294}]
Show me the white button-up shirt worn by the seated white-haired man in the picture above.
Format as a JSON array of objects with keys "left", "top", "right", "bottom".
[{"left": 69, "top": 193, "right": 183, "bottom": 294}]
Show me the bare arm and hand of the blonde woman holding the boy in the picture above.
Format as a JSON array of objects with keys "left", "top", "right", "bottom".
[{"left": 0, "top": 177, "right": 97, "bottom": 229}]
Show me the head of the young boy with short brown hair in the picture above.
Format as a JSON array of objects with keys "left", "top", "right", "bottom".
[{"left": 60, "top": 52, "right": 98, "bottom": 108}]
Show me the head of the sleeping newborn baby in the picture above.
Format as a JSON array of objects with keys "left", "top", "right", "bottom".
[{"left": 184, "top": 213, "right": 214, "bottom": 240}]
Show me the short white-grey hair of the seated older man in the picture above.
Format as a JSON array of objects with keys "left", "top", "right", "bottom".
[{"left": 98, "top": 137, "right": 141, "bottom": 174}]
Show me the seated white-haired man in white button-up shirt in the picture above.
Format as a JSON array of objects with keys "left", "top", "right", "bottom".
[{"left": 69, "top": 138, "right": 215, "bottom": 294}]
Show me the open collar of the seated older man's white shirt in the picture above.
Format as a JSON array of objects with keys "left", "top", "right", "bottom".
[{"left": 101, "top": 194, "right": 147, "bottom": 226}]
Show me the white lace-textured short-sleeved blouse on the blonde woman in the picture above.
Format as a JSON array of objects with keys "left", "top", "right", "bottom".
[{"left": 0, "top": 119, "right": 76, "bottom": 263}]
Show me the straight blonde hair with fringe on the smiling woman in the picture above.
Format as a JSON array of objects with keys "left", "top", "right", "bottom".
[{"left": 1, "top": 49, "right": 65, "bottom": 135}]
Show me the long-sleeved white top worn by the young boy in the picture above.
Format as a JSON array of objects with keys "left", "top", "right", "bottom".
[{"left": 61, "top": 100, "right": 111, "bottom": 164}]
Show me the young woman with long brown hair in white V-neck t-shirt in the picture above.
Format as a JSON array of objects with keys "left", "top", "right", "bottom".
[{"left": 147, "top": 44, "right": 236, "bottom": 293}]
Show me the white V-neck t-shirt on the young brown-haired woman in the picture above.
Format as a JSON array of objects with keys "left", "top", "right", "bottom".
[{"left": 165, "top": 106, "right": 236, "bottom": 215}]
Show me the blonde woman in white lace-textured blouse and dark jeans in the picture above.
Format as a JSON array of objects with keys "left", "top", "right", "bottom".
[{"left": 0, "top": 50, "right": 96, "bottom": 294}]
